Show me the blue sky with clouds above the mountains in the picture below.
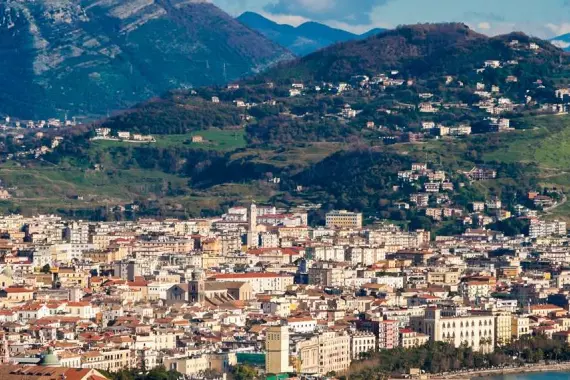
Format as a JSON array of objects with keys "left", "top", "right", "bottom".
[{"left": 212, "top": 0, "right": 570, "bottom": 38}]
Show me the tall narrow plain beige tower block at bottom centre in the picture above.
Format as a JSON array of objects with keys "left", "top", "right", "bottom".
[{"left": 265, "top": 325, "right": 291, "bottom": 374}]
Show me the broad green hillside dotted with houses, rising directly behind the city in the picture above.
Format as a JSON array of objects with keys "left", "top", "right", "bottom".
[{"left": 0, "top": 24, "right": 570, "bottom": 220}]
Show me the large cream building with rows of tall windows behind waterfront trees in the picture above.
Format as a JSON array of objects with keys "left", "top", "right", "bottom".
[{"left": 411, "top": 308, "right": 495, "bottom": 352}]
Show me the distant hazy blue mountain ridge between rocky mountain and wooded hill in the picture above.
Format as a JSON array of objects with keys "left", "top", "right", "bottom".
[{"left": 237, "top": 12, "right": 384, "bottom": 56}]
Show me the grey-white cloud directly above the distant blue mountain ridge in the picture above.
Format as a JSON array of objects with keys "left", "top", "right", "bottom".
[{"left": 263, "top": 0, "right": 390, "bottom": 25}]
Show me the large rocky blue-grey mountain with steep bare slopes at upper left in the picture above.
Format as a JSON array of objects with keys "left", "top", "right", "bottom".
[{"left": 0, "top": 0, "right": 292, "bottom": 119}]
